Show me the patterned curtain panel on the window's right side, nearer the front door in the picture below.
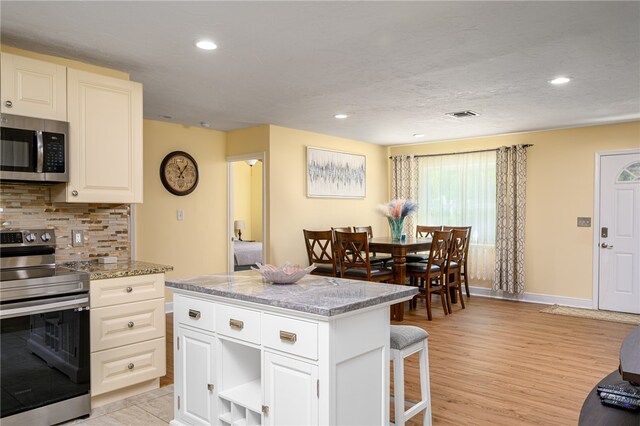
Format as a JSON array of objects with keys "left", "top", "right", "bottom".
[{"left": 493, "top": 145, "right": 527, "bottom": 294}]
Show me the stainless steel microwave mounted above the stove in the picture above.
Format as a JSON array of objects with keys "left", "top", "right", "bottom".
[{"left": 0, "top": 114, "right": 69, "bottom": 183}]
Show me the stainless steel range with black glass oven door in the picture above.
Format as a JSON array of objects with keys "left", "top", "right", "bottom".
[{"left": 0, "top": 229, "right": 91, "bottom": 426}]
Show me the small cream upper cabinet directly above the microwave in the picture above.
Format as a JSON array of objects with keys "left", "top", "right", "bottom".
[{"left": 0, "top": 53, "right": 67, "bottom": 121}]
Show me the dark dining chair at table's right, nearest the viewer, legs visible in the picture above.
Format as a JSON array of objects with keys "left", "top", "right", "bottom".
[{"left": 406, "top": 231, "right": 451, "bottom": 321}]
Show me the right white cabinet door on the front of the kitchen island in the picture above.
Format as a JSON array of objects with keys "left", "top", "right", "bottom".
[{"left": 263, "top": 351, "right": 319, "bottom": 426}]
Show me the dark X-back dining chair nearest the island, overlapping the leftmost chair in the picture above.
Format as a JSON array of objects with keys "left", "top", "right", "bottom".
[{"left": 335, "top": 231, "right": 393, "bottom": 282}]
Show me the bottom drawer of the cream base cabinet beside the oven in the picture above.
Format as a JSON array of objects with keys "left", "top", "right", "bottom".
[{"left": 91, "top": 338, "right": 166, "bottom": 396}]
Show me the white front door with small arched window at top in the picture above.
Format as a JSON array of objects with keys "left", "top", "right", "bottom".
[{"left": 594, "top": 152, "right": 640, "bottom": 314}]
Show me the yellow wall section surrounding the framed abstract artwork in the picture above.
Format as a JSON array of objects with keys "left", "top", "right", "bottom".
[{"left": 269, "top": 126, "right": 389, "bottom": 265}]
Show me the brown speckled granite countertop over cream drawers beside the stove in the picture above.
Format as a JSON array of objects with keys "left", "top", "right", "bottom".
[{"left": 58, "top": 260, "right": 173, "bottom": 280}]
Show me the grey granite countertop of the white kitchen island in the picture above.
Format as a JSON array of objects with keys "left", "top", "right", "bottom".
[{"left": 165, "top": 272, "right": 418, "bottom": 317}]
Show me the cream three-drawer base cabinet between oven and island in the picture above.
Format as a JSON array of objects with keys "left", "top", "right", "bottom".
[{"left": 89, "top": 274, "right": 166, "bottom": 407}]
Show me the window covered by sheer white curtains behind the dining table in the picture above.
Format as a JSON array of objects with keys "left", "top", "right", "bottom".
[{"left": 418, "top": 151, "right": 496, "bottom": 280}]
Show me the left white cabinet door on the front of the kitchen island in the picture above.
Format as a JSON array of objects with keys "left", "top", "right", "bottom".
[{"left": 174, "top": 327, "right": 217, "bottom": 425}]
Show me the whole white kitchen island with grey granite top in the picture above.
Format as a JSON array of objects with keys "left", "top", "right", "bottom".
[{"left": 166, "top": 273, "right": 417, "bottom": 426}]
